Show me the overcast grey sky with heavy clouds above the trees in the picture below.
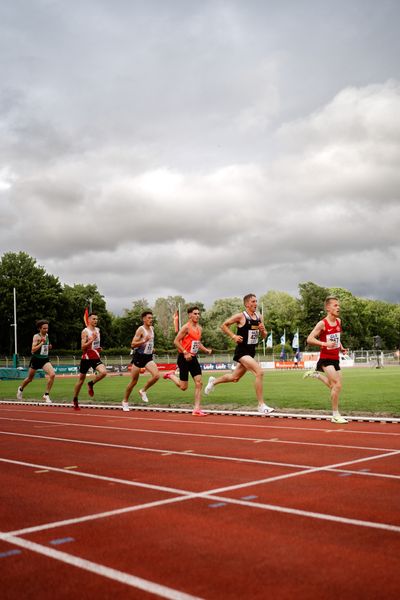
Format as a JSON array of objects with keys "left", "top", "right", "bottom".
[{"left": 0, "top": 0, "right": 400, "bottom": 314}]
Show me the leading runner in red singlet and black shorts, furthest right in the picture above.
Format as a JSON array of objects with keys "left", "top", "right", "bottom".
[{"left": 304, "top": 296, "right": 347, "bottom": 424}]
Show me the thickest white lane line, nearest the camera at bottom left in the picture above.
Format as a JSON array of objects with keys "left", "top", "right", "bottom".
[{"left": 0, "top": 533, "right": 205, "bottom": 600}]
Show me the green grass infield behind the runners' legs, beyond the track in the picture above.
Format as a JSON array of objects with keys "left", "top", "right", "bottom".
[{"left": 0, "top": 367, "right": 400, "bottom": 417}]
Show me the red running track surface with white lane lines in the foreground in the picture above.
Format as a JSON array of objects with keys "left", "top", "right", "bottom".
[{"left": 0, "top": 405, "right": 400, "bottom": 600}]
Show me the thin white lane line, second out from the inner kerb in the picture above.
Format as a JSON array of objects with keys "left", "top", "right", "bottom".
[{"left": 0, "top": 417, "right": 397, "bottom": 452}]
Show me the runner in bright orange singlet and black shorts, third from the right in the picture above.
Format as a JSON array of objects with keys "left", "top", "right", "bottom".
[{"left": 164, "top": 306, "right": 212, "bottom": 417}]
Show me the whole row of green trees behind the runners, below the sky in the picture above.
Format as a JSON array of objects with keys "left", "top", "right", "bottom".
[{"left": 0, "top": 252, "right": 400, "bottom": 355}]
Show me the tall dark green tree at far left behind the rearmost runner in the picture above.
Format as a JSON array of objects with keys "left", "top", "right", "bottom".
[{"left": 0, "top": 252, "right": 62, "bottom": 354}]
